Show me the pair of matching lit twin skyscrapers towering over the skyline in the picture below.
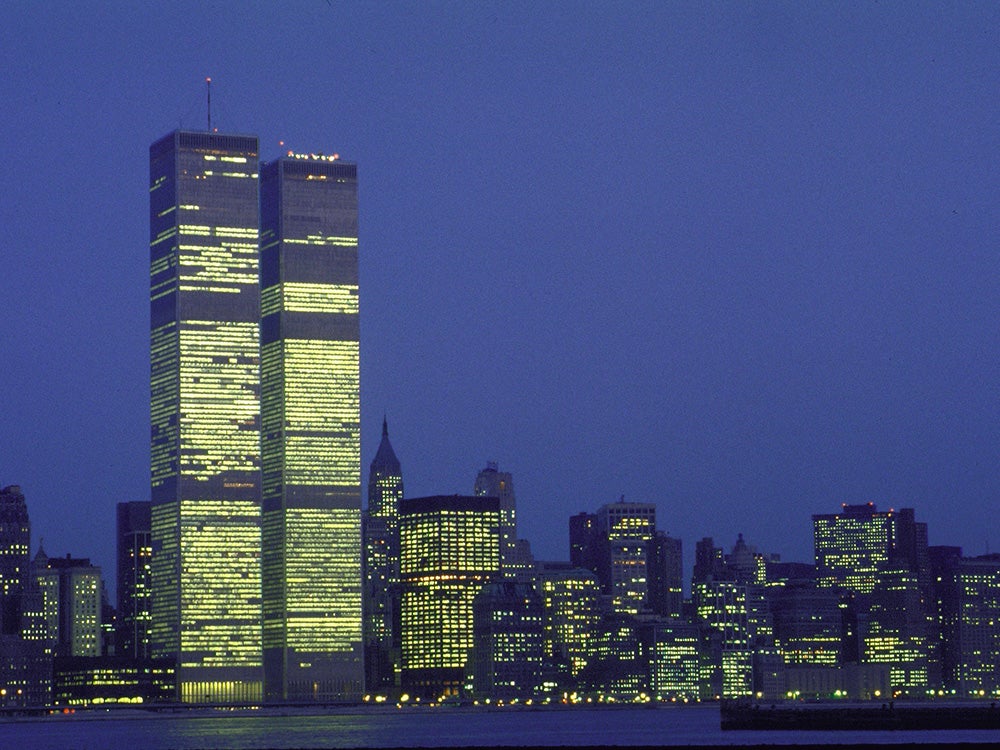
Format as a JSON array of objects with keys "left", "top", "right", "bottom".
[{"left": 149, "top": 131, "right": 363, "bottom": 703}]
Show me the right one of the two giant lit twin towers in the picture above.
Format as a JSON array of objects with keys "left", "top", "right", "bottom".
[{"left": 260, "top": 154, "right": 363, "bottom": 701}]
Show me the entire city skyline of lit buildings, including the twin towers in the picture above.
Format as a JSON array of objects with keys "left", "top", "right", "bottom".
[{"left": 0, "top": 126, "right": 1000, "bottom": 709}]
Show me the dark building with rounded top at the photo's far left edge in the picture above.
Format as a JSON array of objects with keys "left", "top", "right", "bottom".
[{"left": 0, "top": 485, "right": 31, "bottom": 635}]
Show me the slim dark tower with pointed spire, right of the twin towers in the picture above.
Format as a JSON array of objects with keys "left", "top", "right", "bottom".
[{"left": 362, "top": 418, "right": 403, "bottom": 692}]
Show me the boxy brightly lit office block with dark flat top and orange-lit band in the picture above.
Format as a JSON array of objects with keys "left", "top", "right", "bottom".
[{"left": 399, "top": 495, "right": 500, "bottom": 699}]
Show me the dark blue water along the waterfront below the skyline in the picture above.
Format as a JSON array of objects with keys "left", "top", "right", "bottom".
[{"left": 0, "top": 705, "right": 1000, "bottom": 750}]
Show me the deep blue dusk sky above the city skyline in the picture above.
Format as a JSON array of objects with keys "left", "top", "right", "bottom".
[{"left": 0, "top": 0, "right": 1000, "bottom": 592}]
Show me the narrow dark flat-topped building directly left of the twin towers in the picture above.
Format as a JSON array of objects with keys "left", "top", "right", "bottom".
[{"left": 116, "top": 500, "right": 153, "bottom": 659}]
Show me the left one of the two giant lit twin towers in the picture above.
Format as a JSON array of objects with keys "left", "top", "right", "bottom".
[{"left": 149, "top": 131, "right": 262, "bottom": 702}]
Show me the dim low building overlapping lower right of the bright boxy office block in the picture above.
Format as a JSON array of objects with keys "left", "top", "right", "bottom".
[{"left": 471, "top": 580, "right": 544, "bottom": 700}]
